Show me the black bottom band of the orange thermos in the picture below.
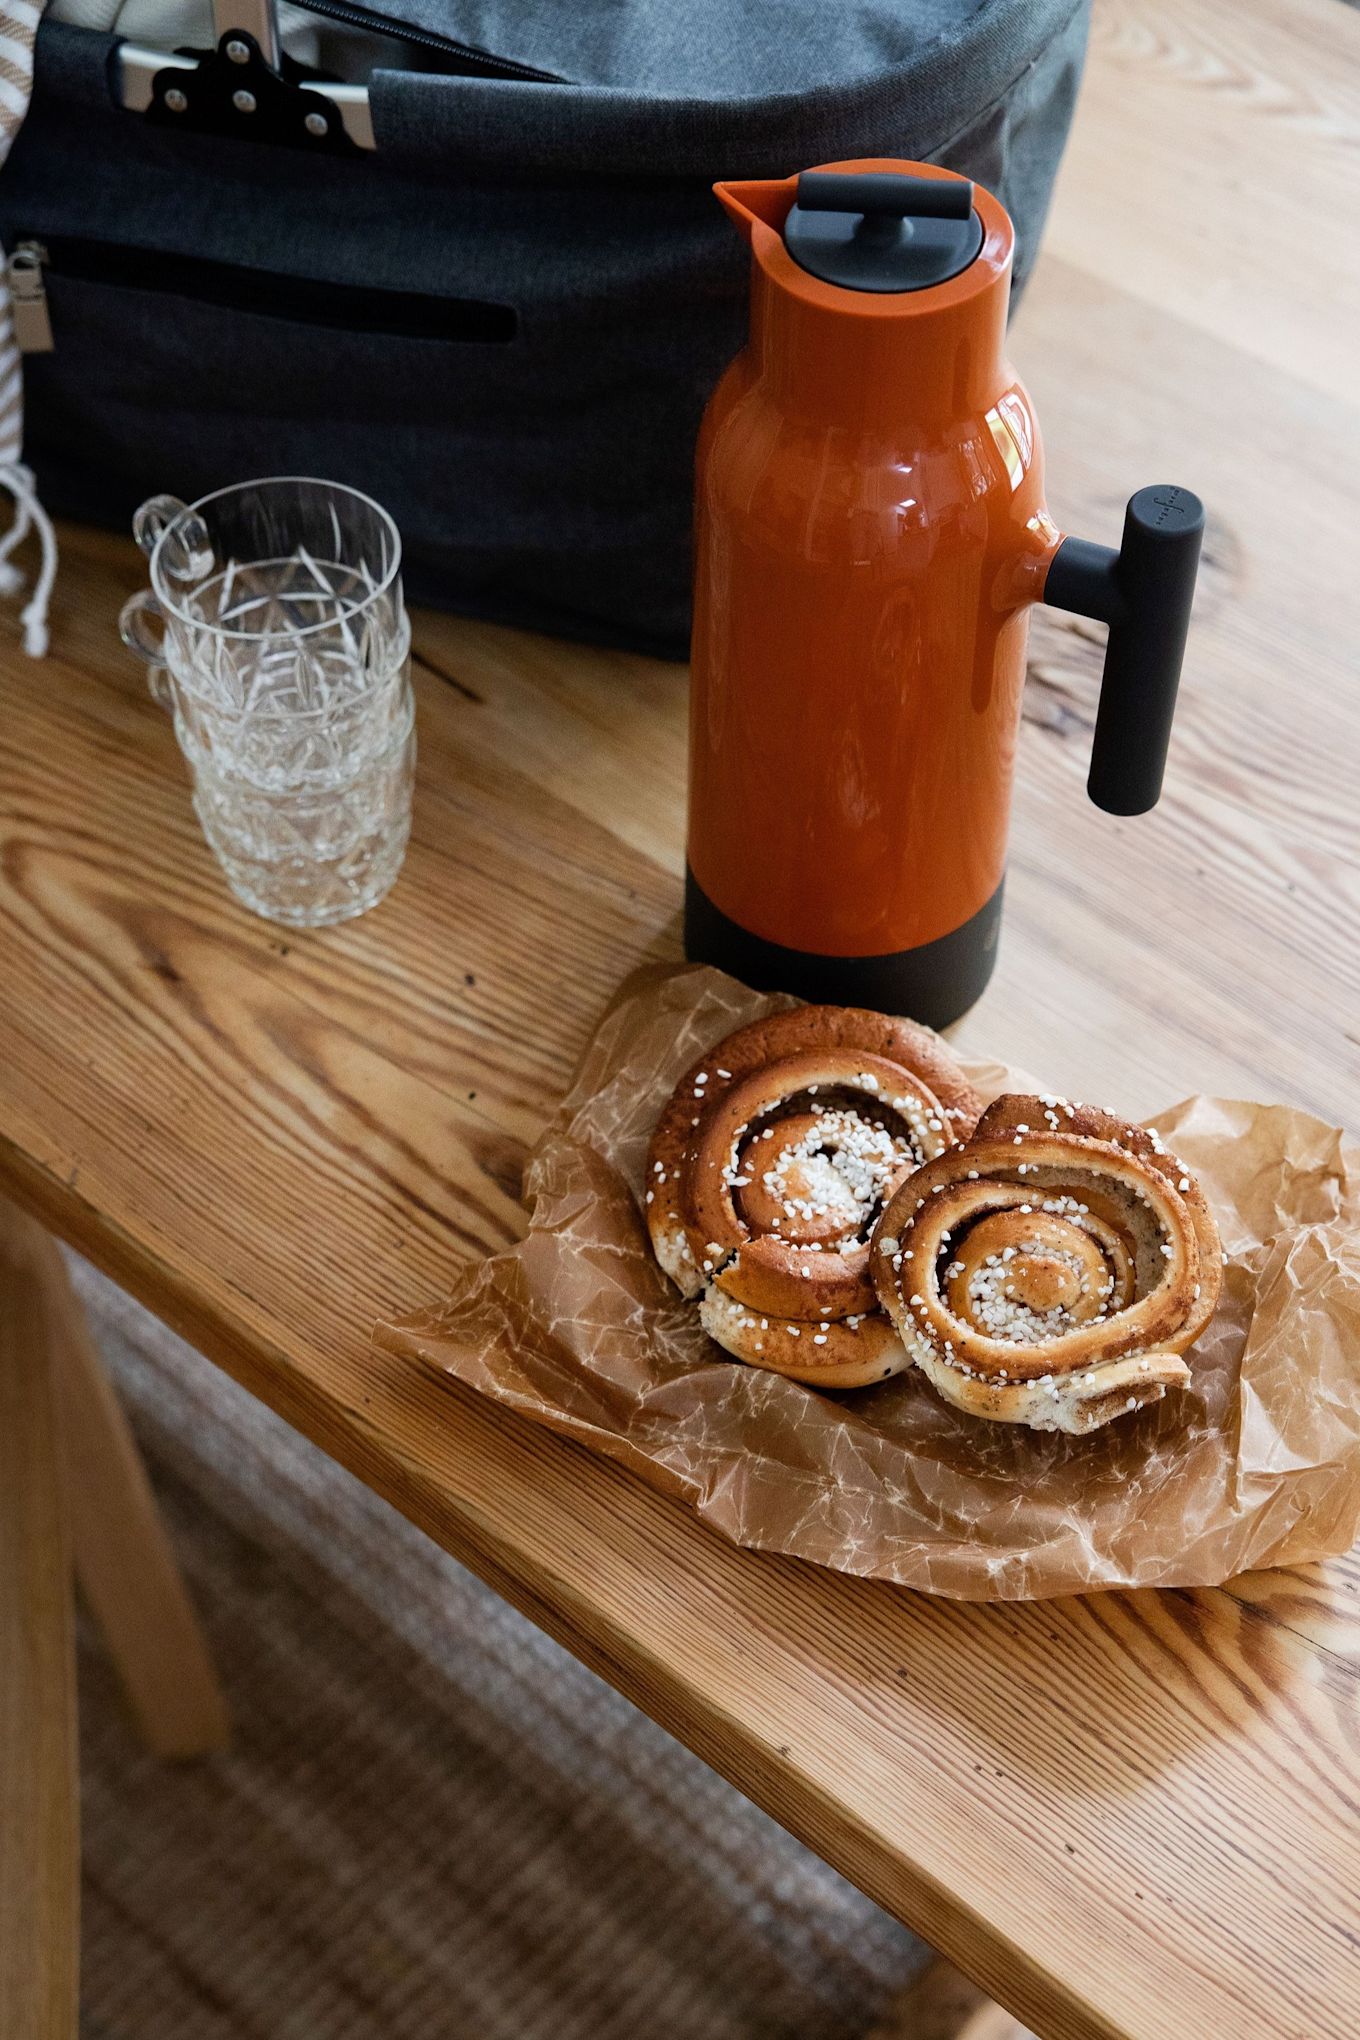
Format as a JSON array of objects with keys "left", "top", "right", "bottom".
[{"left": 685, "top": 871, "right": 1005, "bottom": 1026}]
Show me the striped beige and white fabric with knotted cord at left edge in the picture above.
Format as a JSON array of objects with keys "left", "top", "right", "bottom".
[{"left": 0, "top": 0, "right": 57, "bottom": 659}]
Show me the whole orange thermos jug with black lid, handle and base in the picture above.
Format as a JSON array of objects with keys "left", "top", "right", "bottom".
[{"left": 685, "top": 161, "right": 1203, "bottom": 1026}]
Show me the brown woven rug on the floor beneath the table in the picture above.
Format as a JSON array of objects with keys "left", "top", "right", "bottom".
[{"left": 73, "top": 1263, "right": 924, "bottom": 2040}]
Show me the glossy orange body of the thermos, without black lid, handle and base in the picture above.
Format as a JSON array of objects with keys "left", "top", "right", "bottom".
[{"left": 689, "top": 161, "right": 1058, "bottom": 957}]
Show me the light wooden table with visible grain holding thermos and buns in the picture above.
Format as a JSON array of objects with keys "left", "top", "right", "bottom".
[{"left": 0, "top": 0, "right": 1360, "bottom": 2040}]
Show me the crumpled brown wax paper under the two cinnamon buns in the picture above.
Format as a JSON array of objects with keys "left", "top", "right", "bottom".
[{"left": 375, "top": 967, "right": 1360, "bottom": 1601}]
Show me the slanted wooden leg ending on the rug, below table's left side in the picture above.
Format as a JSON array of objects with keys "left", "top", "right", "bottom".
[{"left": 0, "top": 1206, "right": 228, "bottom": 1756}]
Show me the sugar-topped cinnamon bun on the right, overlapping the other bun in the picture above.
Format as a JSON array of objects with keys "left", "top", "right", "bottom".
[{"left": 871, "top": 1095, "right": 1223, "bottom": 1434}]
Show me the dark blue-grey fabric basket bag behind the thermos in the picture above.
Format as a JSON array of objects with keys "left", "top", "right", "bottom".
[{"left": 0, "top": 0, "right": 1087, "bottom": 657}]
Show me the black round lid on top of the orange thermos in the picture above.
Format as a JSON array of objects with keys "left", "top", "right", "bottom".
[{"left": 783, "top": 169, "right": 983, "bottom": 292}]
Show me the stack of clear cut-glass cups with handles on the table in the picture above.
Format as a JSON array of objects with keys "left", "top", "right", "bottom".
[{"left": 139, "top": 479, "right": 416, "bottom": 928}]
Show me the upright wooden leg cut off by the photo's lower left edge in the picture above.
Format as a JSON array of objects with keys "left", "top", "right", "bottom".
[{"left": 0, "top": 1238, "right": 80, "bottom": 2040}]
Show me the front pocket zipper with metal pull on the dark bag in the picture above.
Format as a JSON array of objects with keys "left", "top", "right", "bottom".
[{"left": 8, "top": 237, "right": 518, "bottom": 353}]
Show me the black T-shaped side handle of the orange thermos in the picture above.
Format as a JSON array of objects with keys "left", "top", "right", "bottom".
[{"left": 1044, "top": 483, "right": 1205, "bottom": 814}]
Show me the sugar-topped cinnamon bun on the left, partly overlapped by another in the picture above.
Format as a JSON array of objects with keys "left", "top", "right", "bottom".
[{"left": 646, "top": 1006, "right": 979, "bottom": 1387}]
